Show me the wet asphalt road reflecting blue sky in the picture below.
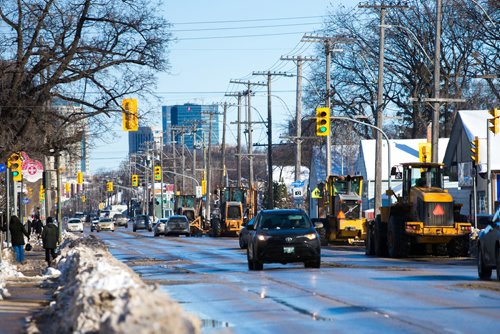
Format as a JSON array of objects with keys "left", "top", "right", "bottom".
[{"left": 95, "top": 229, "right": 500, "bottom": 333}]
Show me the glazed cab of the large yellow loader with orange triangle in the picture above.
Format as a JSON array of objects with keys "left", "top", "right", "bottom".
[{"left": 403, "top": 163, "right": 444, "bottom": 198}]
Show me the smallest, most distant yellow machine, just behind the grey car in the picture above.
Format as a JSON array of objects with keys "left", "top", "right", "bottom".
[{"left": 174, "top": 195, "right": 208, "bottom": 236}]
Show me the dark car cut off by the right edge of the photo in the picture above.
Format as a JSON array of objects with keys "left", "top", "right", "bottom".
[{"left": 477, "top": 208, "right": 500, "bottom": 281}]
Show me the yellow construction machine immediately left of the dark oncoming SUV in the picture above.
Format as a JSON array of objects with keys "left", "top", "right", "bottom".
[{"left": 210, "top": 187, "right": 257, "bottom": 237}]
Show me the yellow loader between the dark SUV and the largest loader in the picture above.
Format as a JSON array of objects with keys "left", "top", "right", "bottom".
[{"left": 319, "top": 175, "right": 366, "bottom": 245}]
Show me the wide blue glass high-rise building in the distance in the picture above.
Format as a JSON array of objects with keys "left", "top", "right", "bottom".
[{"left": 162, "top": 103, "right": 219, "bottom": 148}]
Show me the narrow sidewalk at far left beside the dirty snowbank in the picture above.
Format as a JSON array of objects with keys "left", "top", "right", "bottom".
[{"left": 0, "top": 243, "right": 56, "bottom": 334}]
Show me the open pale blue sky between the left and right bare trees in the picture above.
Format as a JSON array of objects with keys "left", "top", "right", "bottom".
[{"left": 90, "top": 0, "right": 358, "bottom": 172}]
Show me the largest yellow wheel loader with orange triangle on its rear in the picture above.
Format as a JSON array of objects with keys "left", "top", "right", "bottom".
[{"left": 365, "top": 162, "right": 471, "bottom": 258}]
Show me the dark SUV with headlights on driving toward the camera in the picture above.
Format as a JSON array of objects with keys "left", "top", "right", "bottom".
[{"left": 247, "top": 209, "right": 323, "bottom": 270}]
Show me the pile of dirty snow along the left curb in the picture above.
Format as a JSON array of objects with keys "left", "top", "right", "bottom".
[{"left": 28, "top": 236, "right": 200, "bottom": 333}]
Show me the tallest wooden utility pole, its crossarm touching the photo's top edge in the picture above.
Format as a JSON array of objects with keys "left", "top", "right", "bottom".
[{"left": 358, "top": 1, "right": 408, "bottom": 215}]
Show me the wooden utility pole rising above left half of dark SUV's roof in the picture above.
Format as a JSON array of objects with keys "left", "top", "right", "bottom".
[{"left": 252, "top": 71, "right": 292, "bottom": 209}]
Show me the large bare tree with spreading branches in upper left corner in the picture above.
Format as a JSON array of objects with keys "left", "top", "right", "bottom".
[{"left": 0, "top": 0, "right": 171, "bottom": 159}]
